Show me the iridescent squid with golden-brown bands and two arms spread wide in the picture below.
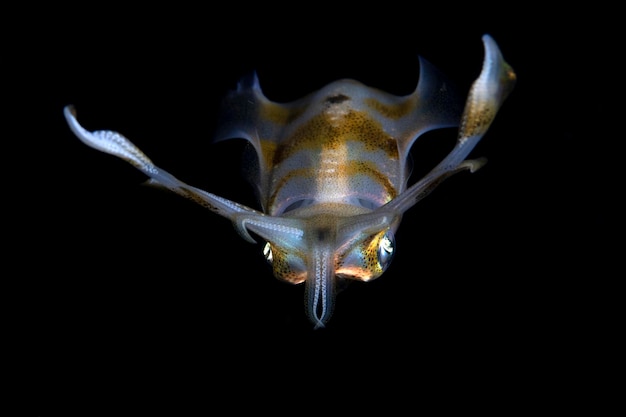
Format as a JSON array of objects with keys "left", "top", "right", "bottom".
[{"left": 64, "top": 35, "right": 515, "bottom": 328}]
